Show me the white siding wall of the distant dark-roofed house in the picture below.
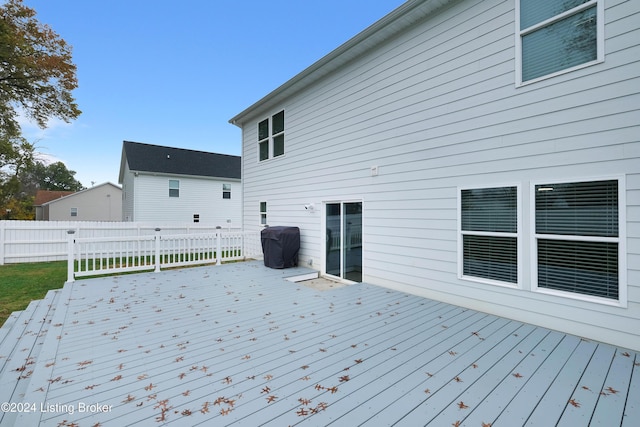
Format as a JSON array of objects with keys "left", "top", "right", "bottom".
[{"left": 133, "top": 173, "right": 242, "bottom": 227}]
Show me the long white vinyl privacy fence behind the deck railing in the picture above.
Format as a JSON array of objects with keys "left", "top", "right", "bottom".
[{"left": 0, "top": 221, "right": 239, "bottom": 265}]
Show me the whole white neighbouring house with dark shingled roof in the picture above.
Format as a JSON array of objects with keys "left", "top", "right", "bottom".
[{"left": 119, "top": 141, "right": 242, "bottom": 227}]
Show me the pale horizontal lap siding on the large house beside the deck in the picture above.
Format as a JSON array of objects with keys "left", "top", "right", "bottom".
[{"left": 243, "top": 0, "right": 640, "bottom": 348}]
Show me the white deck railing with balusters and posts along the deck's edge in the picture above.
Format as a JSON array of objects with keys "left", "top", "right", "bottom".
[{"left": 67, "top": 229, "right": 262, "bottom": 282}]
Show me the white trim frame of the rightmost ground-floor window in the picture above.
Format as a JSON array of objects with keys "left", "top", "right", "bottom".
[{"left": 529, "top": 175, "right": 627, "bottom": 308}]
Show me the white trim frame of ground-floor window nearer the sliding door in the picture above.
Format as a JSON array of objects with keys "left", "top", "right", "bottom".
[{"left": 457, "top": 183, "right": 523, "bottom": 289}]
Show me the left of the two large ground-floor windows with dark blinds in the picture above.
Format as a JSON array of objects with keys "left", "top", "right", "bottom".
[{"left": 458, "top": 186, "right": 520, "bottom": 286}]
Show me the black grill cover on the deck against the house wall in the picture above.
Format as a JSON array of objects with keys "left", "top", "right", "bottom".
[{"left": 260, "top": 226, "right": 300, "bottom": 268}]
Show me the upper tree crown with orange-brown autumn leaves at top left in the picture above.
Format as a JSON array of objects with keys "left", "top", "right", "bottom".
[{"left": 0, "top": 0, "right": 81, "bottom": 138}]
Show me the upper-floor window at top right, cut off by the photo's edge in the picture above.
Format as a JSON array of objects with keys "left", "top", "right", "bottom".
[{"left": 516, "top": 0, "right": 604, "bottom": 83}]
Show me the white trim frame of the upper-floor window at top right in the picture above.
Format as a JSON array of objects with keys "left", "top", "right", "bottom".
[{"left": 515, "top": 0, "right": 605, "bottom": 87}]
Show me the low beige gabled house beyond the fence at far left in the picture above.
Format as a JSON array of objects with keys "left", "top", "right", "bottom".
[{"left": 34, "top": 182, "right": 122, "bottom": 221}]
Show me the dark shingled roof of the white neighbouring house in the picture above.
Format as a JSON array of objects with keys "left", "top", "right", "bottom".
[{"left": 123, "top": 141, "right": 241, "bottom": 179}]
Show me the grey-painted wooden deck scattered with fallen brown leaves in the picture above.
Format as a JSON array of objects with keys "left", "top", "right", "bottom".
[{"left": 0, "top": 262, "right": 640, "bottom": 427}]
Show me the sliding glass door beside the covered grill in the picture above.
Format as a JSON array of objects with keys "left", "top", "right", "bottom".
[{"left": 325, "top": 202, "right": 362, "bottom": 282}]
